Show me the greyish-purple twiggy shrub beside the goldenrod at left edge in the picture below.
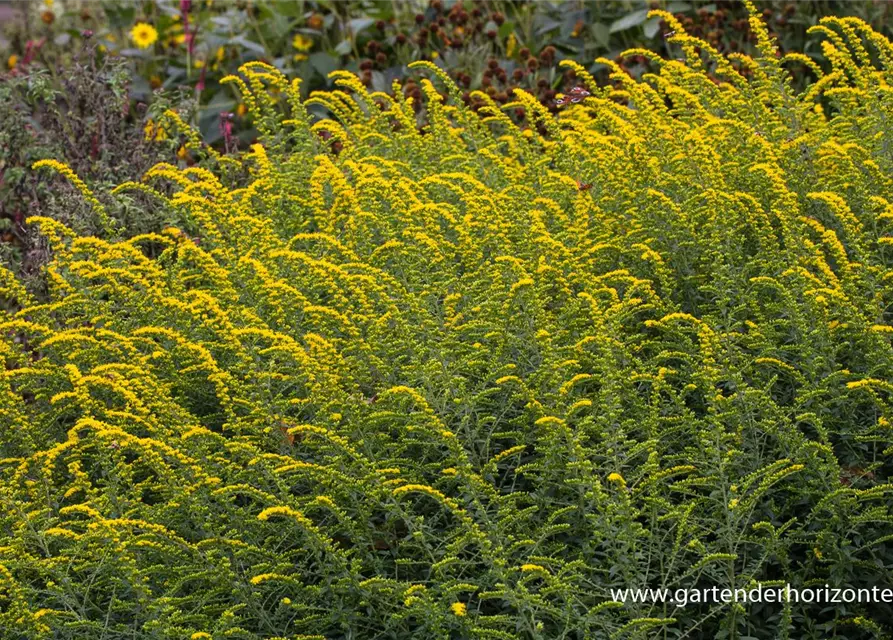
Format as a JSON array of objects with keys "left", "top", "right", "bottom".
[{"left": 0, "top": 46, "right": 204, "bottom": 288}]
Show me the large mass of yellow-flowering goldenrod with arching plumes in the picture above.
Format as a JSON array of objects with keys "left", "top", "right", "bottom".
[{"left": 0, "top": 5, "right": 893, "bottom": 640}]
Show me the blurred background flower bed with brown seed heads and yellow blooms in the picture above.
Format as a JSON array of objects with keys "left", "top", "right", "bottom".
[{"left": 6, "top": 0, "right": 893, "bottom": 134}]
